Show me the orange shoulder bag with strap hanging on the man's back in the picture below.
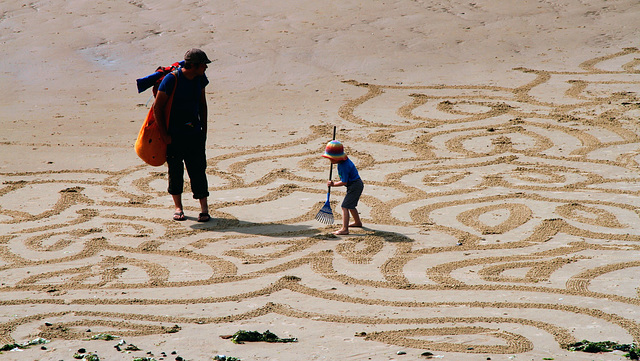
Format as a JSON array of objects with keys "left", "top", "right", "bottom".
[{"left": 135, "top": 72, "right": 178, "bottom": 167}]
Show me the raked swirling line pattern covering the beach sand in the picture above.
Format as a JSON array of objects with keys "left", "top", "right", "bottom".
[{"left": 0, "top": 49, "right": 640, "bottom": 354}]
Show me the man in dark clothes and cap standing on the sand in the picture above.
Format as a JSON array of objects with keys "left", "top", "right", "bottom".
[{"left": 154, "top": 49, "right": 211, "bottom": 222}]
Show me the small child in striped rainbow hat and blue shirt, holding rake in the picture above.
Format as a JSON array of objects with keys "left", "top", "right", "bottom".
[{"left": 322, "top": 140, "right": 364, "bottom": 235}]
